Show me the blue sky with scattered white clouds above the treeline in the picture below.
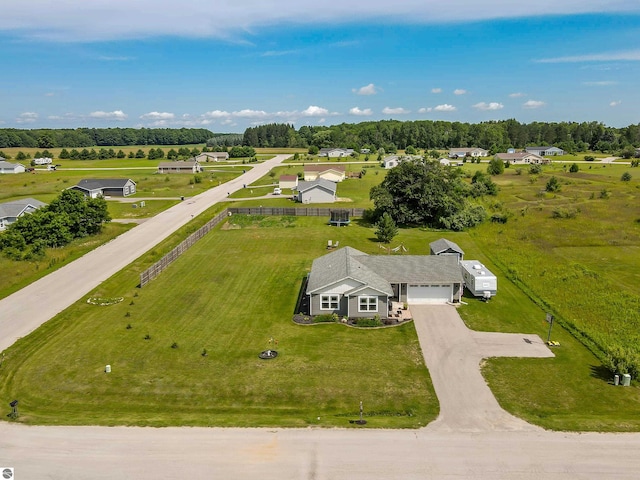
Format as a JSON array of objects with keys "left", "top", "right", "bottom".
[{"left": 0, "top": 0, "right": 640, "bottom": 132}]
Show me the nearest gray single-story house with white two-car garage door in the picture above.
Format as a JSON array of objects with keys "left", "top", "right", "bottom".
[{"left": 306, "top": 247, "right": 463, "bottom": 318}]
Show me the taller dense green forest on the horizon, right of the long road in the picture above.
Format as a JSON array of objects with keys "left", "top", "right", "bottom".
[{"left": 244, "top": 120, "right": 640, "bottom": 153}]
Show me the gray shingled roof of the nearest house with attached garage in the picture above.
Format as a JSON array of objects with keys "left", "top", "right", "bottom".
[{"left": 307, "top": 247, "right": 462, "bottom": 296}]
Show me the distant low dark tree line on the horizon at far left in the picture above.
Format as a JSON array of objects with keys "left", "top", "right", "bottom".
[{"left": 0, "top": 128, "right": 215, "bottom": 148}]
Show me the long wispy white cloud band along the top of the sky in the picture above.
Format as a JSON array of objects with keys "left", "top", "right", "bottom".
[{"left": 6, "top": 0, "right": 640, "bottom": 42}]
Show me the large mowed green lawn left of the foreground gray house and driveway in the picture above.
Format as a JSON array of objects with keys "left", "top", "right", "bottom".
[{"left": 0, "top": 218, "right": 438, "bottom": 428}]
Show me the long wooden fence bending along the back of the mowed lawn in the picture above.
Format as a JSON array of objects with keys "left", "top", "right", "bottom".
[{"left": 140, "top": 207, "right": 364, "bottom": 287}]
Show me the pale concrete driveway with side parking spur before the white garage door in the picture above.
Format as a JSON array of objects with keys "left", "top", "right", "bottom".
[{"left": 410, "top": 305, "right": 553, "bottom": 432}]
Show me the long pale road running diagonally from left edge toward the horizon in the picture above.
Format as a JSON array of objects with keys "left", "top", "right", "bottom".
[{"left": 0, "top": 155, "right": 290, "bottom": 352}]
